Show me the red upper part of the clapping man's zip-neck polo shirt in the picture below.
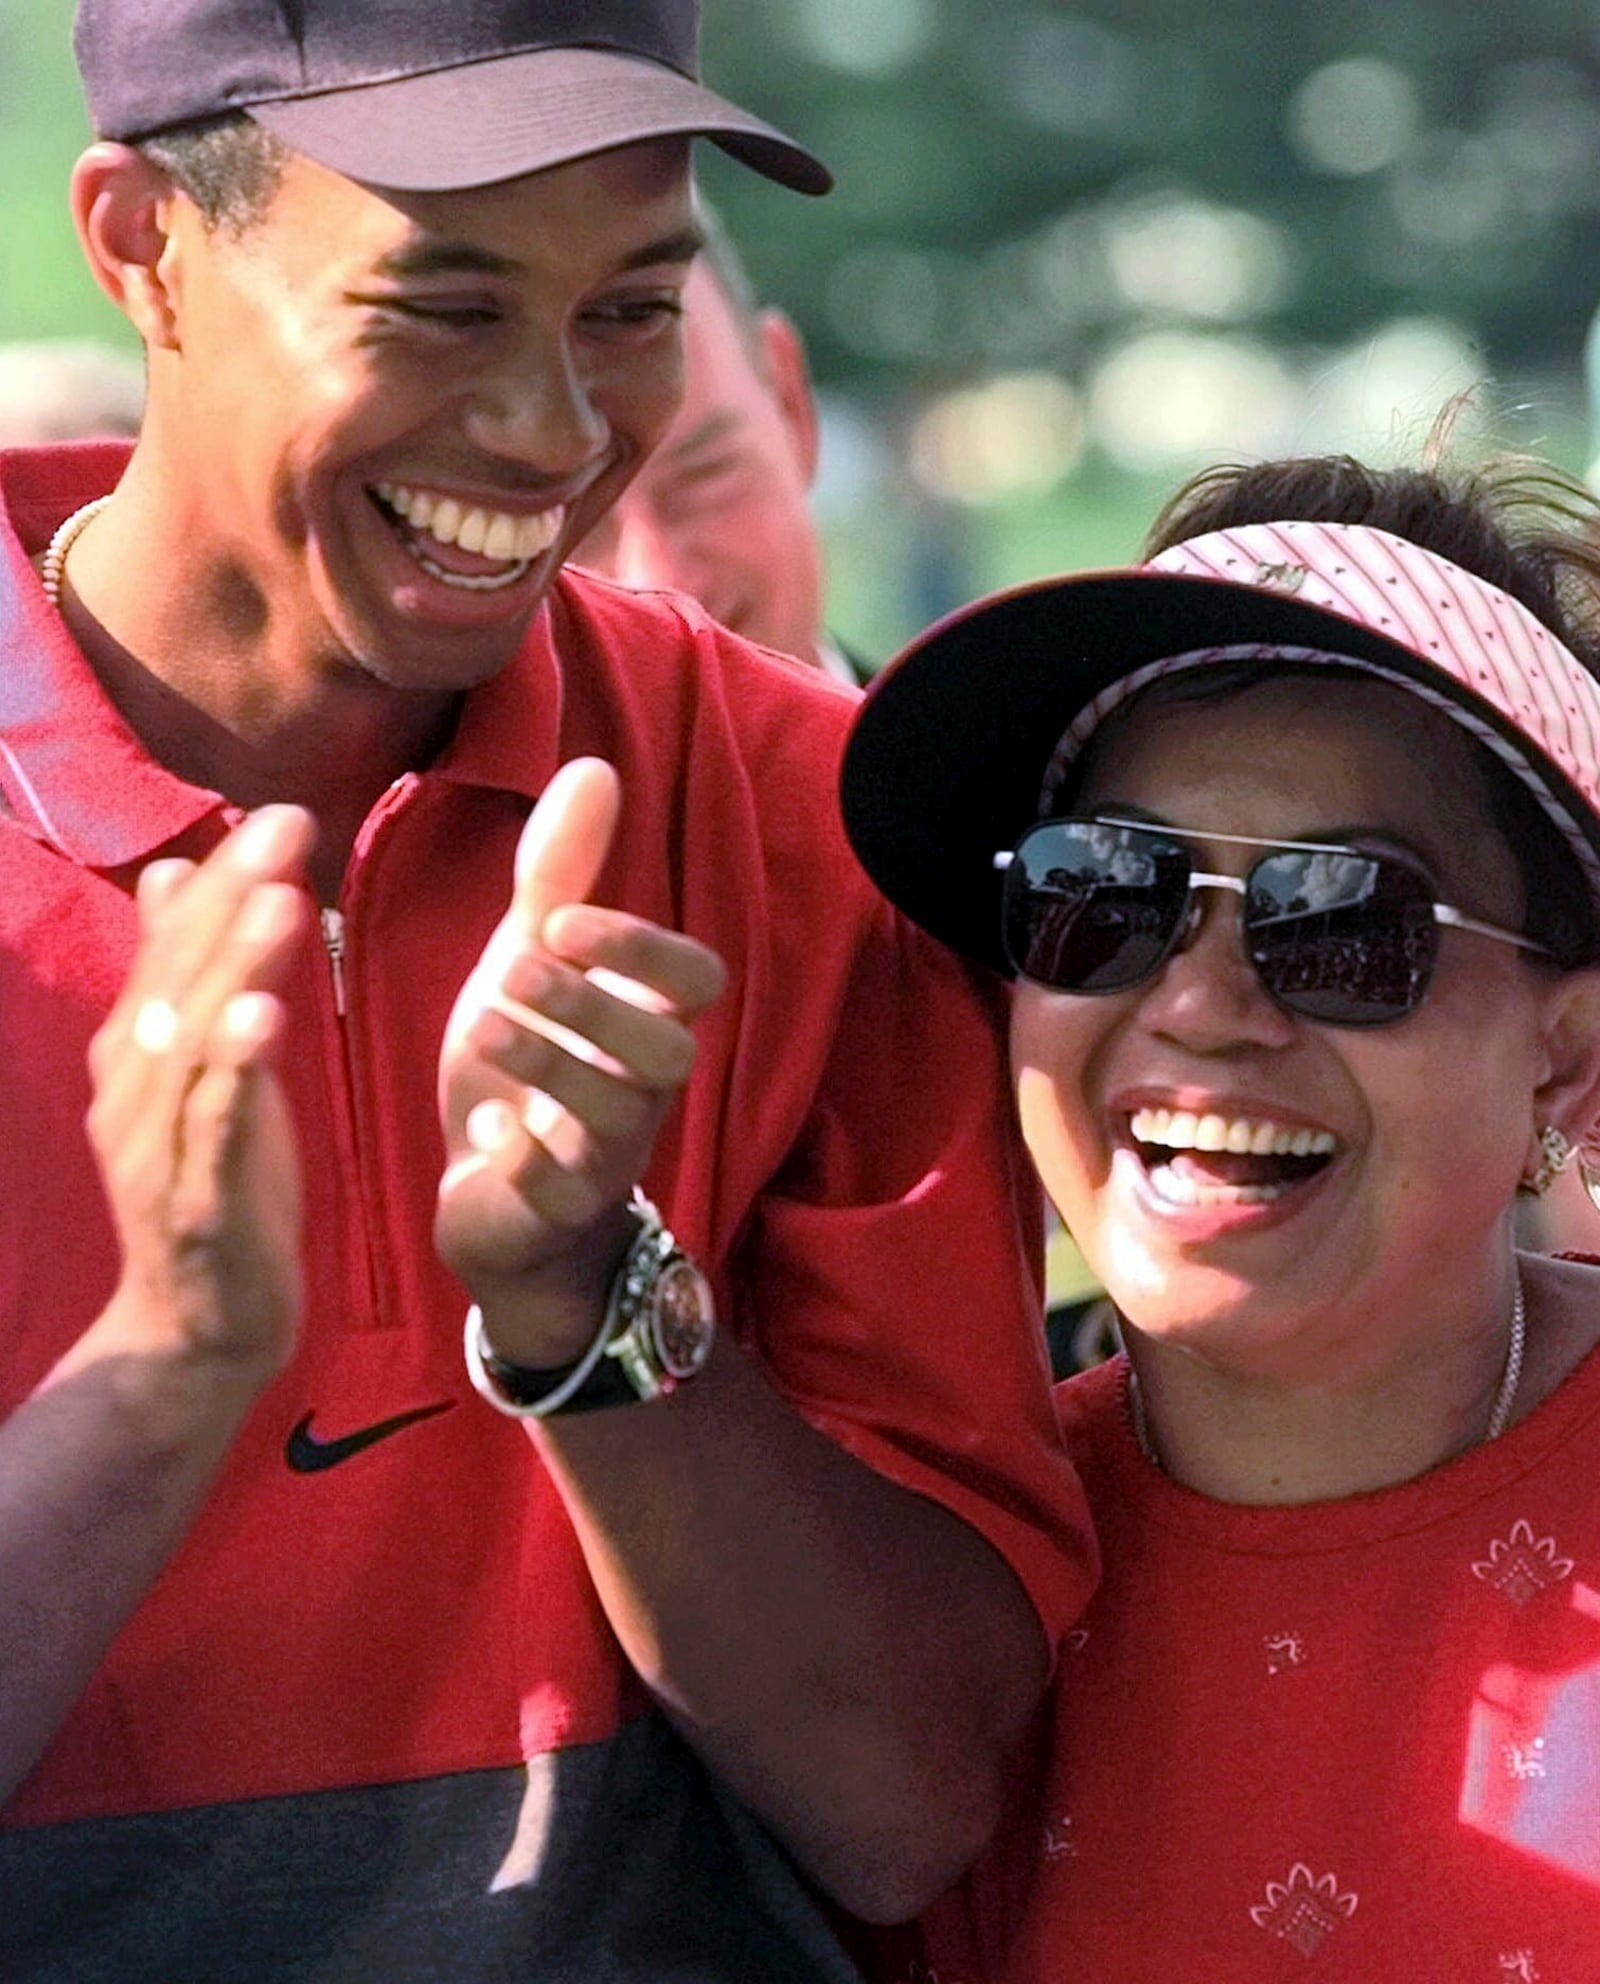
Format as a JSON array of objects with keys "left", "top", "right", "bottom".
[{"left": 0, "top": 448, "right": 1094, "bottom": 1827}]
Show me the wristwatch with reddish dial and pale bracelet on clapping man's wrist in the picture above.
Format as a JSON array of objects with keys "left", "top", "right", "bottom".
[{"left": 465, "top": 1192, "right": 717, "bottom": 1419}]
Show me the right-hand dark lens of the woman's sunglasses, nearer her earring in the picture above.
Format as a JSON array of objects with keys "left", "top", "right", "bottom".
[{"left": 1245, "top": 851, "right": 1439, "bottom": 1026}]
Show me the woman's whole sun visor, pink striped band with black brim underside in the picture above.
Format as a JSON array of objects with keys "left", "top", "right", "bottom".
[{"left": 840, "top": 522, "right": 1600, "bottom": 992}]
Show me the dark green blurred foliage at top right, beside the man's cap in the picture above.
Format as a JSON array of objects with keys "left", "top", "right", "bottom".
[{"left": 705, "top": 0, "right": 1600, "bottom": 398}]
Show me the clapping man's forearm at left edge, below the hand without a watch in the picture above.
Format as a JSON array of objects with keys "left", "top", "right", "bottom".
[{"left": 0, "top": 1305, "right": 260, "bottom": 1805}]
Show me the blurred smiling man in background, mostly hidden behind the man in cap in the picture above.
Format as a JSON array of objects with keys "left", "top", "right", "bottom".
[{"left": 576, "top": 208, "right": 864, "bottom": 682}]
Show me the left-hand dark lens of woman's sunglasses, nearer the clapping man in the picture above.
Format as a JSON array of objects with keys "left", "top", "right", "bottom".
[{"left": 1002, "top": 819, "right": 1189, "bottom": 992}]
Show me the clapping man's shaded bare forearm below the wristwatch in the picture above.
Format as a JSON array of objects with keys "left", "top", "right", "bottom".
[{"left": 536, "top": 1343, "right": 1048, "bottom": 1921}]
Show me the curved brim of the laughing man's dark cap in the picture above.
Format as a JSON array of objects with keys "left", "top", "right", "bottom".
[{"left": 242, "top": 48, "right": 834, "bottom": 192}]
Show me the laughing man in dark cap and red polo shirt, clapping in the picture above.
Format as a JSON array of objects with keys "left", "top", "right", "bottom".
[{"left": 0, "top": 0, "right": 1092, "bottom": 1984}]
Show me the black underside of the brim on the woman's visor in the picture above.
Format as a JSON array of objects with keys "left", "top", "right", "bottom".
[{"left": 840, "top": 569, "right": 1600, "bottom": 976}]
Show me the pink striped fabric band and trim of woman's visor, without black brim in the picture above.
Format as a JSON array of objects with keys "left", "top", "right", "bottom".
[{"left": 1040, "top": 524, "right": 1600, "bottom": 899}]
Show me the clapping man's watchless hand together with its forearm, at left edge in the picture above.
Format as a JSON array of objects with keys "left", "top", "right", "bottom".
[{"left": 0, "top": 806, "right": 312, "bottom": 1803}]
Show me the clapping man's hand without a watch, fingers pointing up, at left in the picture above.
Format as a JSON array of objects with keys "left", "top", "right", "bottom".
[{"left": 89, "top": 806, "right": 314, "bottom": 1381}]
